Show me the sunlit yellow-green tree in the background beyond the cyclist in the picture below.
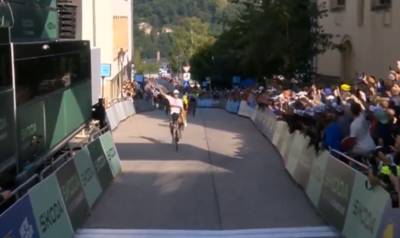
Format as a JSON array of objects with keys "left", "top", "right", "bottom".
[{"left": 170, "top": 18, "right": 215, "bottom": 72}]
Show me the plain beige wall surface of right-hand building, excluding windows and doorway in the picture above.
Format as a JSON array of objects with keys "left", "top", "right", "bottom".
[{"left": 318, "top": 0, "right": 400, "bottom": 78}]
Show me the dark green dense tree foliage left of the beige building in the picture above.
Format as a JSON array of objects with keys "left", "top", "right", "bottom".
[{"left": 191, "top": 0, "right": 330, "bottom": 85}]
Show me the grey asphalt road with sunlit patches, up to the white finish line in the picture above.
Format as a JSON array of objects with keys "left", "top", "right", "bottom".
[{"left": 85, "top": 109, "right": 325, "bottom": 230}]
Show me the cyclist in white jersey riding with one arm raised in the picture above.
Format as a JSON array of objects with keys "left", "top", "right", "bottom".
[{"left": 160, "top": 89, "right": 183, "bottom": 141}]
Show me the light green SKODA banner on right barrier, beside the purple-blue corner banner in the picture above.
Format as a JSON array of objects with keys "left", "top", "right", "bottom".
[{"left": 343, "top": 172, "right": 390, "bottom": 238}]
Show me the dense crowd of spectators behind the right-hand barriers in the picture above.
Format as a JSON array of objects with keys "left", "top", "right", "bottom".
[{"left": 247, "top": 61, "right": 400, "bottom": 206}]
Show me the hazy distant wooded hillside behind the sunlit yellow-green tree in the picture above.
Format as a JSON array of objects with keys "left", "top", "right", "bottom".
[{"left": 134, "top": 0, "right": 231, "bottom": 59}]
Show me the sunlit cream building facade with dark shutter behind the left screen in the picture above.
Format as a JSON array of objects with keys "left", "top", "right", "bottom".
[{"left": 58, "top": 0, "right": 133, "bottom": 101}]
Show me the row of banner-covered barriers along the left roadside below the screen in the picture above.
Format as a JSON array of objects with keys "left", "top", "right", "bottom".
[{"left": 0, "top": 132, "right": 121, "bottom": 238}]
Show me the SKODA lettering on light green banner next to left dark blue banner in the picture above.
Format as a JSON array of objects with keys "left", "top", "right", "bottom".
[{"left": 39, "top": 200, "right": 64, "bottom": 233}]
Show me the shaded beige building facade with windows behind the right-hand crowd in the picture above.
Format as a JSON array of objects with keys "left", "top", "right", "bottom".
[{"left": 316, "top": 0, "right": 400, "bottom": 82}]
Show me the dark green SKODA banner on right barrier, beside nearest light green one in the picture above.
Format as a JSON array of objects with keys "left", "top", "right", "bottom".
[{"left": 318, "top": 159, "right": 355, "bottom": 231}]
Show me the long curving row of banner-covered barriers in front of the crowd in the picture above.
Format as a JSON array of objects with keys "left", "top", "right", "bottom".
[{"left": 227, "top": 101, "right": 400, "bottom": 238}]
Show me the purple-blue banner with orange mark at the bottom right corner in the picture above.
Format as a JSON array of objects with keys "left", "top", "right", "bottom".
[{"left": 376, "top": 201, "right": 400, "bottom": 238}]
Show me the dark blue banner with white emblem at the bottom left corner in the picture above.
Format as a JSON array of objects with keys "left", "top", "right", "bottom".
[{"left": 0, "top": 196, "right": 39, "bottom": 238}]
